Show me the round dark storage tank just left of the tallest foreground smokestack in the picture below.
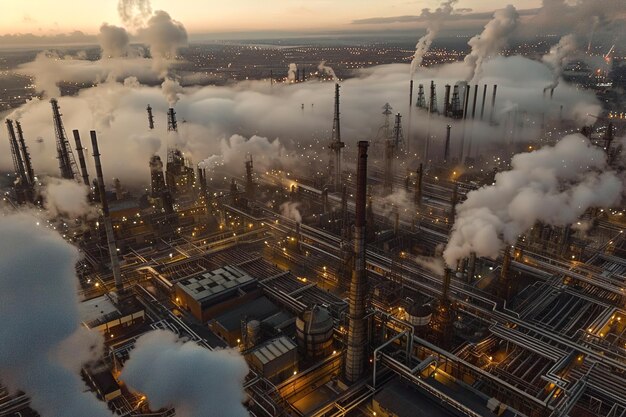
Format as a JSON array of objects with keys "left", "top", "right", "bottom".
[{"left": 296, "top": 305, "right": 333, "bottom": 359}]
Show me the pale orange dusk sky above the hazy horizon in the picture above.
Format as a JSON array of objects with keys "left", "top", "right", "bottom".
[{"left": 0, "top": 0, "right": 541, "bottom": 36}]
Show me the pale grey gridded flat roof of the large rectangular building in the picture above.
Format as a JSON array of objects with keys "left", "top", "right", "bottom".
[{"left": 178, "top": 266, "right": 254, "bottom": 301}]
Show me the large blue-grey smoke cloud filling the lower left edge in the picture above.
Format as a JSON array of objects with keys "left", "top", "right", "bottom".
[{"left": 0, "top": 214, "right": 112, "bottom": 417}]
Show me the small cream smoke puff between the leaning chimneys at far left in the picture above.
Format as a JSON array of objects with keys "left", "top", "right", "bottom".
[{"left": 41, "top": 177, "right": 98, "bottom": 219}]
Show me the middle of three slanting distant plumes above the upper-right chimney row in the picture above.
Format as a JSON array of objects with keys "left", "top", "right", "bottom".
[{"left": 465, "top": 5, "right": 519, "bottom": 82}]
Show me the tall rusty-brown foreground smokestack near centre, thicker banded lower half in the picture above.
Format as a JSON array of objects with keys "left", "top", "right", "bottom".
[{"left": 345, "top": 141, "right": 369, "bottom": 382}]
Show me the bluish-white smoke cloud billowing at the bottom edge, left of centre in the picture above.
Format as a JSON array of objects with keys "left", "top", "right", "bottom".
[{"left": 121, "top": 330, "right": 249, "bottom": 417}]
